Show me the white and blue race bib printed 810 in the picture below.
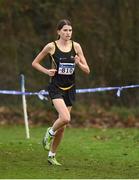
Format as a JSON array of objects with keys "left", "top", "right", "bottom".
[{"left": 58, "top": 63, "right": 75, "bottom": 75}]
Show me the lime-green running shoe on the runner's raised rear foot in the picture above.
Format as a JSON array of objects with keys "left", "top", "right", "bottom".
[{"left": 42, "top": 127, "right": 53, "bottom": 151}]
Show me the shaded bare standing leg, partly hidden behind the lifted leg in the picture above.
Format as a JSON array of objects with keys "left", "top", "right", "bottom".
[{"left": 50, "top": 107, "right": 72, "bottom": 153}]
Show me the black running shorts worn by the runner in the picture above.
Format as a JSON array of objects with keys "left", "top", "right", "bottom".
[{"left": 48, "top": 83, "right": 76, "bottom": 106}]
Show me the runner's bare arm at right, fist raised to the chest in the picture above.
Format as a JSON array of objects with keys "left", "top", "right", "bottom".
[{"left": 75, "top": 43, "right": 90, "bottom": 74}]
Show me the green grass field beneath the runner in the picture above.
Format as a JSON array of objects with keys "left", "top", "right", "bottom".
[{"left": 0, "top": 126, "right": 139, "bottom": 179}]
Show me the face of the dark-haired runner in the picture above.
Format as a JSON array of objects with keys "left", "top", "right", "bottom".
[{"left": 58, "top": 25, "right": 72, "bottom": 41}]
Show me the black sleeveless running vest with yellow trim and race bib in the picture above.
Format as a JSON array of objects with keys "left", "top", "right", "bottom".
[{"left": 50, "top": 41, "right": 76, "bottom": 88}]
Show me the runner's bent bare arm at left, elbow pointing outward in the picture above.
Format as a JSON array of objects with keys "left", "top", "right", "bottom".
[{"left": 32, "top": 43, "right": 56, "bottom": 76}]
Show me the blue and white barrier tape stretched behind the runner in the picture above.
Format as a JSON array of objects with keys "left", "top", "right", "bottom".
[{"left": 0, "top": 85, "right": 139, "bottom": 100}]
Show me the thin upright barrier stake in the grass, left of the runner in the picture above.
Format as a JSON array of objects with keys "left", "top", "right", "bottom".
[{"left": 21, "top": 74, "right": 30, "bottom": 139}]
